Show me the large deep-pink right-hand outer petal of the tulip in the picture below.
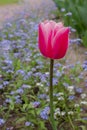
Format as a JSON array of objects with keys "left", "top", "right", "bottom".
[{"left": 52, "top": 27, "right": 69, "bottom": 59}]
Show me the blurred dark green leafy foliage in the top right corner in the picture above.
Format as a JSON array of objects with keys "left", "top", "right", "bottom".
[{"left": 54, "top": 0, "right": 87, "bottom": 47}]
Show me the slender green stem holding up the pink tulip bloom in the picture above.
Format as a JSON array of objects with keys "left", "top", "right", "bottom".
[{"left": 49, "top": 59, "right": 57, "bottom": 130}]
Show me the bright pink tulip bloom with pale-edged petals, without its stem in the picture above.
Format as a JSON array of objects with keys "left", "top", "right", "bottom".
[{"left": 39, "top": 21, "right": 69, "bottom": 59}]
